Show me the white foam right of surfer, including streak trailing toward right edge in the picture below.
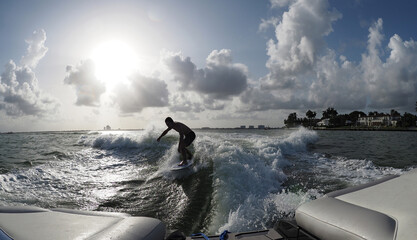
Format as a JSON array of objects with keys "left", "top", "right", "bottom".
[{"left": 204, "top": 128, "right": 401, "bottom": 233}]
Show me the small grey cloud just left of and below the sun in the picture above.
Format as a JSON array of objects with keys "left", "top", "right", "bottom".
[{"left": 64, "top": 59, "right": 106, "bottom": 106}]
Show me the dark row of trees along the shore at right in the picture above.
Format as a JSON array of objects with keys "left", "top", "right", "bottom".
[{"left": 284, "top": 102, "right": 417, "bottom": 128}]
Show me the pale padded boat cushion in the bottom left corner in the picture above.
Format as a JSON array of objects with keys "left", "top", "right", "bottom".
[{"left": 0, "top": 206, "right": 165, "bottom": 240}]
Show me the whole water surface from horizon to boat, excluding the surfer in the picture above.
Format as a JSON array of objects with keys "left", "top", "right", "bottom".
[{"left": 0, "top": 127, "right": 417, "bottom": 234}]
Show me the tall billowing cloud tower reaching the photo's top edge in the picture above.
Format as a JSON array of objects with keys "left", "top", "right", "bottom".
[{"left": 262, "top": 0, "right": 341, "bottom": 88}]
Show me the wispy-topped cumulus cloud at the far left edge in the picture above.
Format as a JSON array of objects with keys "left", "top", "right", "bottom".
[{"left": 0, "top": 30, "right": 59, "bottom": 117}]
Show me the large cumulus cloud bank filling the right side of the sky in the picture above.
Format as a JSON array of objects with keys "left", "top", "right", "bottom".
[{"left": 244, "top": 0, "right": 417, "bottom": 111}]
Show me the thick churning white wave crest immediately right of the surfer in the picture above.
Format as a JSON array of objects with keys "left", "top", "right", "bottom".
[{"left": 196, "top": 128, "right": 317, "bottom": 233}]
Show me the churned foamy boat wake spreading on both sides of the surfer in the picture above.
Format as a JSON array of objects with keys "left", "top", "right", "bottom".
[{"left": 0, "top": 127, "right": 403, "bottom": 234}]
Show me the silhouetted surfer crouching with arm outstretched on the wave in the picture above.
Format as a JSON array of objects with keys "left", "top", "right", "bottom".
[{"left": 157, "top": 117, "right": 195, "bottom": 166}]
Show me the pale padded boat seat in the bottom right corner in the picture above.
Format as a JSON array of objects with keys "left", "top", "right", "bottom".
[{"left": 295, "top": 170, "right": 417, "bottom": 240}]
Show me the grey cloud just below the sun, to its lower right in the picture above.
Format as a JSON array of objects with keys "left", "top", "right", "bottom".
[{"left": 114, "top": 73, "right": 168, "bottom": 114}]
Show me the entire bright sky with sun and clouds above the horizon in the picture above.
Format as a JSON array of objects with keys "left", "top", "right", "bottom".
[{"left": 0, "top": 0, "right": 417, "bottom": 132}]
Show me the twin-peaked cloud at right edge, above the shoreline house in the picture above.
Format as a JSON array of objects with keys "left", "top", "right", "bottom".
[{"left": 362, "top": 19, "right": 417, "bottom": 108}]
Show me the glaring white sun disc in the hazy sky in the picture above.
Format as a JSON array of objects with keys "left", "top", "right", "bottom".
[{"left": 91, "top": 40, "right": 138, "bottom": 84}]
